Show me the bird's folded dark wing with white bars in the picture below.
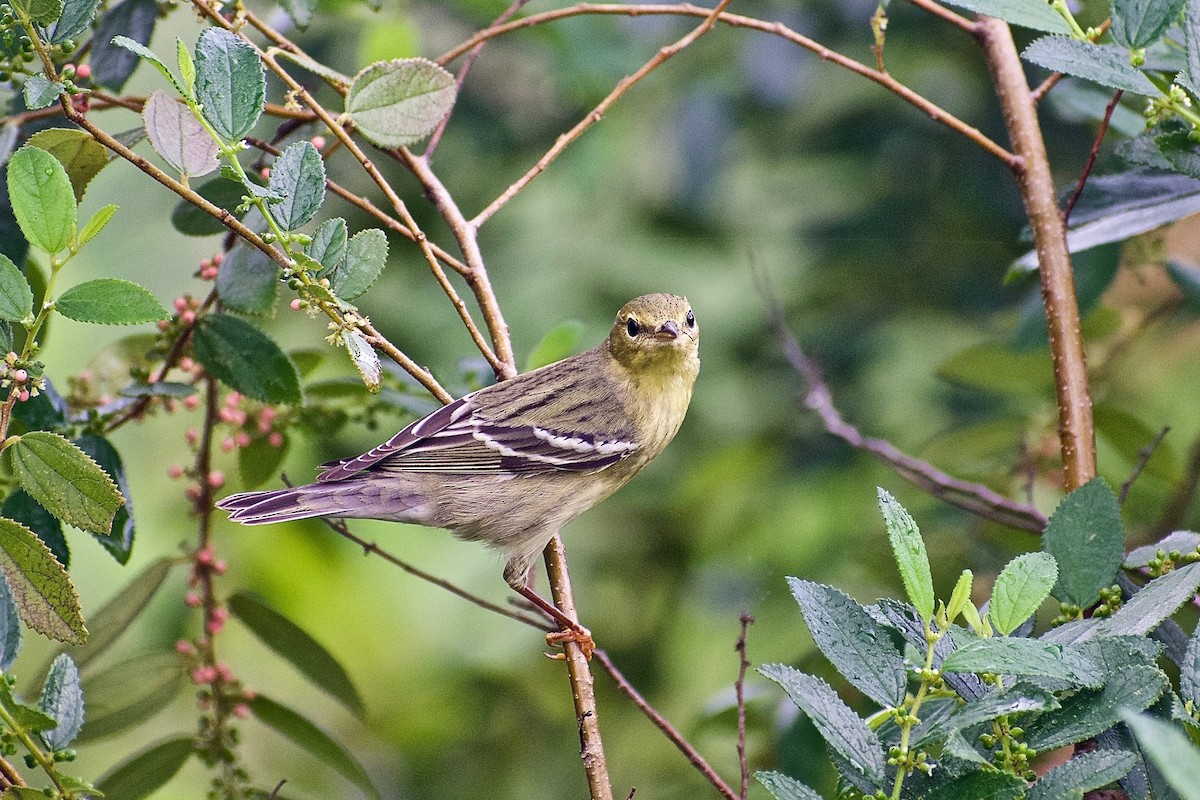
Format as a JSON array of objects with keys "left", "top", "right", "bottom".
[{"left": 317, "top": 395, "right": 637, "bottom": 483}]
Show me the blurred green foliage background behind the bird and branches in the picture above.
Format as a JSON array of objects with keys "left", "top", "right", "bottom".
[{"left": 17, "top": 0, "right": 1200, "bottom": 800}]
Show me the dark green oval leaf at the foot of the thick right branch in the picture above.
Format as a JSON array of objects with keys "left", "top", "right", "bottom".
[{"left": 1042, "top": 477, "right": 1124, "bottom": 608}]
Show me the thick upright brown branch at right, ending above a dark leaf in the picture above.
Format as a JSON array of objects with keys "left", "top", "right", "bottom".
[{"left": 976, "top": 17, "right": 1096, "bottom": 492}]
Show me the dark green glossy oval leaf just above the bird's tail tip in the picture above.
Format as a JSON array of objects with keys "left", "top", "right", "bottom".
[{"left": 192, "top": 314, "right": 302, "bottom": 404}]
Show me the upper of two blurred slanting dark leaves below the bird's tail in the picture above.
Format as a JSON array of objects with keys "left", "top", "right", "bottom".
[{"left": 229, "top": 591, "right": 366, "bottom": 716}]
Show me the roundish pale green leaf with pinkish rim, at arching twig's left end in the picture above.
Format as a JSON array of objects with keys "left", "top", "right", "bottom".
[{"left": 346, "top": 59, "right": 457, "bottom": 148}]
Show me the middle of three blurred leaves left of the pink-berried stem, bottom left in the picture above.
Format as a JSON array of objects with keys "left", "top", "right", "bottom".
[{"left": 76, "top": 652, "right": 185, "bottom": 745}]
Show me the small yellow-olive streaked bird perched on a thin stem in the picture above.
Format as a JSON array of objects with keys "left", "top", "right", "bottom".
[{"left": 217, "top": 294, "right": 700, "bottom": 638}]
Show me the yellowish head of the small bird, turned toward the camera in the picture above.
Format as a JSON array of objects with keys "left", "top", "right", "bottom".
[{"left": 608, "top": 294, "right": 700, "bottom": 372}]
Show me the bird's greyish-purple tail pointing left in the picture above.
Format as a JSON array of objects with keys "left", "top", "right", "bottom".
[{"left": 217, "top": 481, "right": 420, "bottom": 525}]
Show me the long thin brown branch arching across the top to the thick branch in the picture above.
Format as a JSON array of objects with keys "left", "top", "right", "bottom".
[{"left": 436, "top": 2, "right": 1018, "bottom": 167}]
